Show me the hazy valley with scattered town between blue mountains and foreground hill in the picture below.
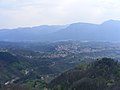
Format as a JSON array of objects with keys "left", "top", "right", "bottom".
[{"left": 0, "top": 41, "right": 120, "bottom": 90}]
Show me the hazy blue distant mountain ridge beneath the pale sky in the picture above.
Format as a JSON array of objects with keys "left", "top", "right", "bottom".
[{"left": 0, "top": 20, "right": 120, "bottom": 41}]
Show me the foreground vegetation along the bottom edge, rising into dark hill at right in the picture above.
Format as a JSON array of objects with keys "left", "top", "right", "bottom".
[{"left": 0, "top": 58, "right": 120, "bottom": 90}]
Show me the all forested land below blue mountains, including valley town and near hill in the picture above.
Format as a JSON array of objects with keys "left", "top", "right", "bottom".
[{"left": 0, "top": 41, "right": 120, "bottom": 90}]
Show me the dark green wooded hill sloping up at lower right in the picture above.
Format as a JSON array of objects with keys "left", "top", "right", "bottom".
[{"left": 49, "top": 58, "right": 120, "bottom": 90}]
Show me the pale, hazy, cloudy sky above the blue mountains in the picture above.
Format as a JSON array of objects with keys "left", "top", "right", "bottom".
[{"left": 0, "top": 0, "right": 120, "bottom": 28}]
